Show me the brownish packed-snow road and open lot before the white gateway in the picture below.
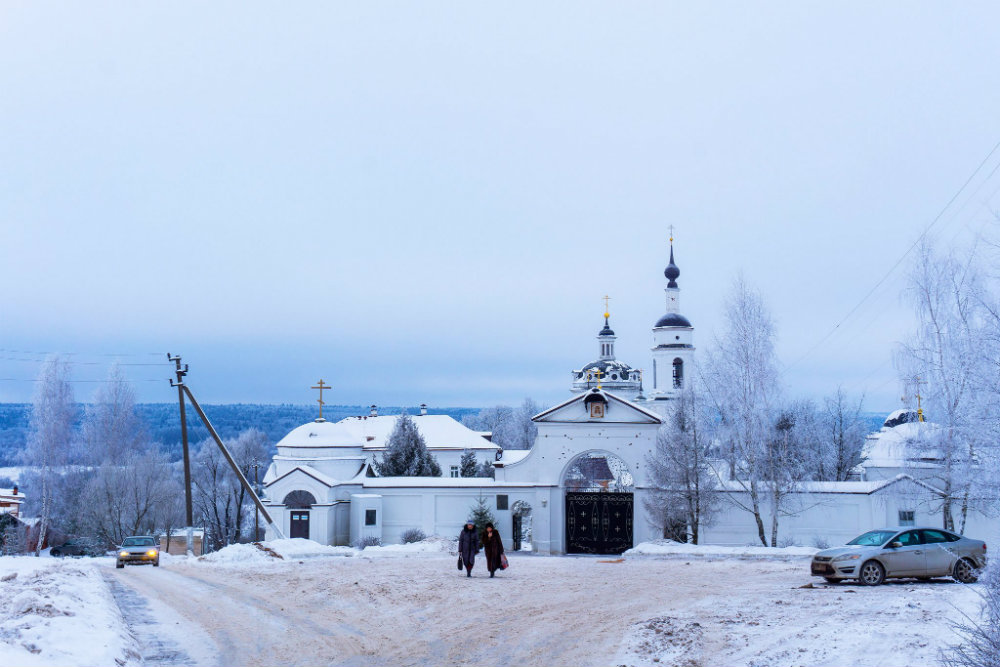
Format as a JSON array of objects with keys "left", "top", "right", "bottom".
[{"left": 109, "top": 555, "right": 976, "bottom": 666}]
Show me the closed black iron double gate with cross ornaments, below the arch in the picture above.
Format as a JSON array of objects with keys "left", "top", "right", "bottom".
[{"left": 566, "top": 492, "right": 632, "bottom": 554}]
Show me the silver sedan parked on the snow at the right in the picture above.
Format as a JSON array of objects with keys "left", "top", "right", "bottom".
[{"left": 812, "top": 528, "right": 986, "bottom": 586}]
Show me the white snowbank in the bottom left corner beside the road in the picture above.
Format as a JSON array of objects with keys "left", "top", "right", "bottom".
[{"left": 0, "top": 556, "right": 140, "bottom": 667}]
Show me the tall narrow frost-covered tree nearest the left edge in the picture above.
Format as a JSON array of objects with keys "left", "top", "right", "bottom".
[{"left": 21, "top": 356, "right": 76, "bottom": 556}]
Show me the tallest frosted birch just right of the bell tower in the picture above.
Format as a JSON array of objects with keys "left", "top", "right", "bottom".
[{"left": 704, "top": 277, "right": 781, "bottom": 546}]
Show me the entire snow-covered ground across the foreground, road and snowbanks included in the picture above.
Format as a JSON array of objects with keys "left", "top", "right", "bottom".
[{"left": 0, "top": 539, "right": 978, "bottom": 667}]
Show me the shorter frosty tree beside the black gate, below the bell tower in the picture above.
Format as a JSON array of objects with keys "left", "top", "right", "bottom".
[{"left": 645, "top": 384, "right": 720, "bottom": 544}]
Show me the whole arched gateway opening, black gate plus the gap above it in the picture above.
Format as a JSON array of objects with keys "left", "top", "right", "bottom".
[{"left": 562, "top": 451, "right": 635, "bottom": 554}]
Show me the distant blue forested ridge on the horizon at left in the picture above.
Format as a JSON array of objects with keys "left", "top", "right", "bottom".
[{"left": 0, "top": 403, "right": 479, "bottom": 466}]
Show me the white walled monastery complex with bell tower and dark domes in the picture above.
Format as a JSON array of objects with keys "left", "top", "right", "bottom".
[{"left": 264, "top": 238, "right": 996, "bottom": 554}]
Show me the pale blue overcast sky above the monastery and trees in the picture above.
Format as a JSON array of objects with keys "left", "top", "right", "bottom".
[{"left": 0, "top": 0, "right": 1000, "bottom": 411}]
